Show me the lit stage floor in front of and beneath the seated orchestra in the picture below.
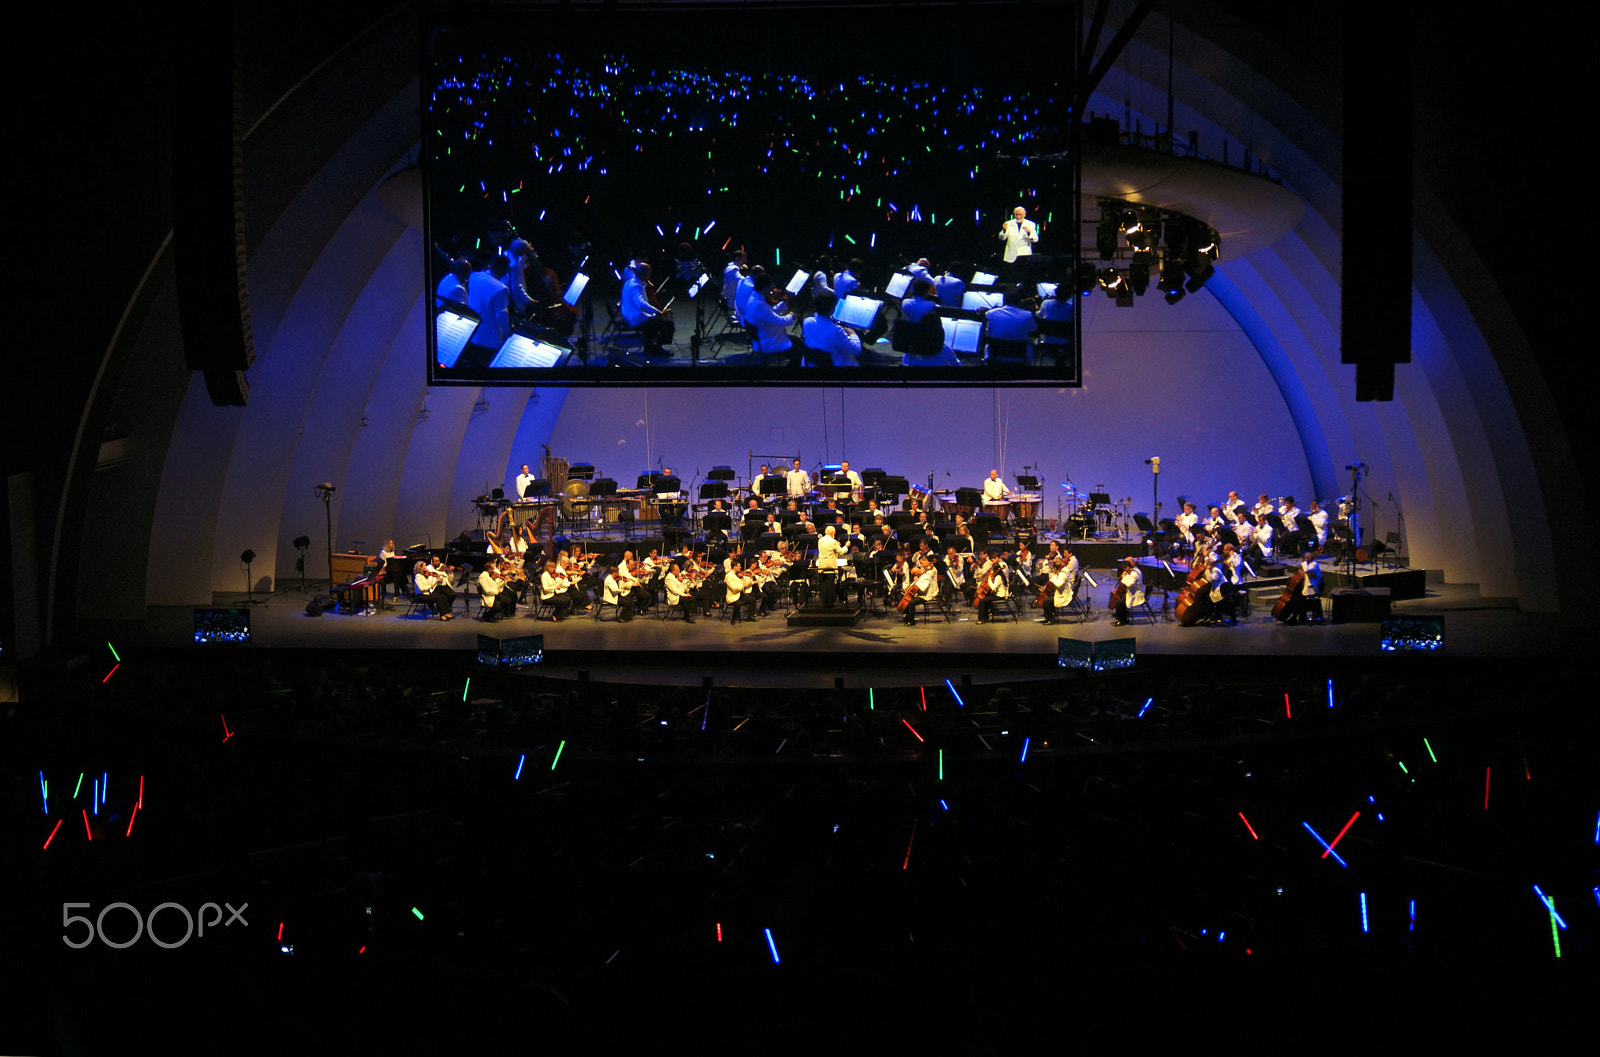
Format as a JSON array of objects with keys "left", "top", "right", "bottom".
[{"left": 99, "top": 584, "right": 1576, "bottom": 686}]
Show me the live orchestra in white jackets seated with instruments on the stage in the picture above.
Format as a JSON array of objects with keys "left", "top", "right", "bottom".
[{"left": 336, "top": 457, "right": 1352, "bottom": 627}]
